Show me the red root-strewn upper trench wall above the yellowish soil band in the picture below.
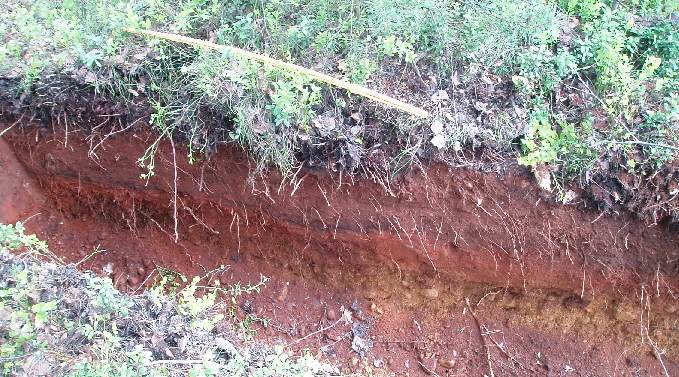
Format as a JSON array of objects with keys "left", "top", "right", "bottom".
[{"left": 6, "top": 131, "right": 679, "bottom": 296}]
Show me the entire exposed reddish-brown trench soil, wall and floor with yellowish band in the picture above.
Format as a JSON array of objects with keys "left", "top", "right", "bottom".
[{"left": 0, "top": 131, "right": 679, "bottom": 376}]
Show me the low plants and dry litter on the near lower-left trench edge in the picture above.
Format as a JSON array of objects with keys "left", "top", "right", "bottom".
[{"left": 0, "top": 223, "right": 339, "bottom": 377}]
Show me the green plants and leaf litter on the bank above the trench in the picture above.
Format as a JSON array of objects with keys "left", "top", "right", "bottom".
[{"left": 0, "top": 0, "right": 679, "bottom": 215}]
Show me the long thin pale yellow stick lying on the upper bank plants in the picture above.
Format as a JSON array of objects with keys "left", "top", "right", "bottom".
[{"left": 123, "top": 28, "right": 429, "bottom": 118}]
